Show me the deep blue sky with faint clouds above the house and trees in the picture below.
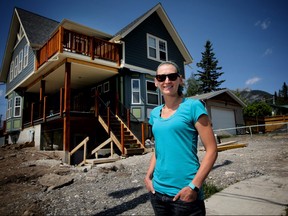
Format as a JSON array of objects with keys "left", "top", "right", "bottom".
[{"left": 0, "top": 0, "right": 288, "bottom": 117}]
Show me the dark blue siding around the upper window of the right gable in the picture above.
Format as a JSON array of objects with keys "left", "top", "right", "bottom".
[{"left": 124, "top": 12, "right": 184, "bottom": 75}]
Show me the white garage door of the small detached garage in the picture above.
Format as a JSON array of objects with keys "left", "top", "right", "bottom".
[{"left": 211, "top": 107, "right": 236, "bottom": 135}]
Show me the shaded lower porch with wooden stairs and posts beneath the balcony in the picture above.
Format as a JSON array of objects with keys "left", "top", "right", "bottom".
[{"left": 23, "top": 89, "right": 148, "bottom": 164}]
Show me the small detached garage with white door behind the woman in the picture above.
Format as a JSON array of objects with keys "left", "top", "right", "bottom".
[{"left": 191, "top": 89, "right": 246, "bottom": 135}]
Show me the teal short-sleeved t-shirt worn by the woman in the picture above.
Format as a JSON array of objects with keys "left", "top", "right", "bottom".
[{"left": 149, "top": 98, "right": 207, "bottom": 199}]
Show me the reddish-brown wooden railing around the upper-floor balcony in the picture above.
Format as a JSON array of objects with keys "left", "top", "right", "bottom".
[{"left": 37, "top": 27, "right": 121, "bottom": 69}]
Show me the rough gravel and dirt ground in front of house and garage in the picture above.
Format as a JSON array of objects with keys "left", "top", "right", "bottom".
[{"left": 0, "top": 133, "right": 288, "bottom": 215}]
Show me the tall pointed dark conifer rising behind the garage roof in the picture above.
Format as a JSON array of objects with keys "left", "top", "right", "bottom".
[{"left": 195, "top": 40, "right": 225, "bottom": 93}]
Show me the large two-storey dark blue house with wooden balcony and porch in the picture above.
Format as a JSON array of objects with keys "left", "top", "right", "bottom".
[{"left": 0, "top": 3, "right": 192, "bottom": 163}]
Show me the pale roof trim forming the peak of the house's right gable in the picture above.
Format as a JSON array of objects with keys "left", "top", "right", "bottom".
[{"left": 111, "top": 3, "right": 193, "bottom": 64}]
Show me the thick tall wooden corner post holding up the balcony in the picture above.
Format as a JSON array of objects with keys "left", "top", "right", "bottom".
[{"left": 63, "top": 62, "right": 71, "bottom": 162}]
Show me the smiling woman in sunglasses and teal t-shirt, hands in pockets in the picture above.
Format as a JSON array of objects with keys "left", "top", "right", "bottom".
[{"left": 144, "top": 62, "right": 217, "bottom": 216}]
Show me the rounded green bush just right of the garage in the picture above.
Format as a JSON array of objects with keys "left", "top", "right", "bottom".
[{"left": 243, "top": 101, "right": 272, "bottom": 117}]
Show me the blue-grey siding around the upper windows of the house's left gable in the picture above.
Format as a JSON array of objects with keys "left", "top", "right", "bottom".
[{"left": 6, "top": 37, "right": 34, "bottom": 92}]
